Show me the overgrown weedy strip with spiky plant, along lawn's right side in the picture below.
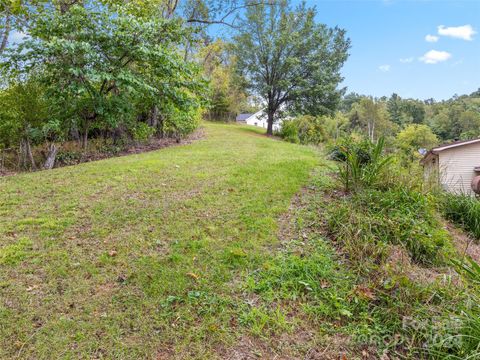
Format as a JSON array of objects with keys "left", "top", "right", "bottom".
[{"left": 320, "top": 139, "right": 468, "bottom": 358}]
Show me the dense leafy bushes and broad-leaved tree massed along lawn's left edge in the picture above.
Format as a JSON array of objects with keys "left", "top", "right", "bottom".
[{"left": 0, "top": 1, "right": 207, "bottom": 169}]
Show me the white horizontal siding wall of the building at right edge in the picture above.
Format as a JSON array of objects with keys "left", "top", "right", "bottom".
[{"left": 438, "top": 143, "right": 480, "bottom": 194}]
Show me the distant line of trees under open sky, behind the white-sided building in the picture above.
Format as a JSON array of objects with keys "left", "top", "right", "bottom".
[{"left": 280, "top": 90, "right": 480, "bottom": 161}]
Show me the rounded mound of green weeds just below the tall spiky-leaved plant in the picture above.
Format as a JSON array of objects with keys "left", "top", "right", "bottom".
[{"left": 326, "top": 185, "right": 450, "bottom": 270}]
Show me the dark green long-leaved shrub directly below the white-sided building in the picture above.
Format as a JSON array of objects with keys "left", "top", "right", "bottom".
[{"left": 441, "top": 193, "right": 480, "bottom": 240}]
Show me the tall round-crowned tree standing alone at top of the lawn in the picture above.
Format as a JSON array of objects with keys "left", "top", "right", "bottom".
[{"left": 235, "top": 0, "right": 350, "bottom": 134}]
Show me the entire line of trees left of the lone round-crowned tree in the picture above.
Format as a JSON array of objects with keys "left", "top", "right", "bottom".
[{"left": 0, "top": 0, "right": 268, "bottom": 169}]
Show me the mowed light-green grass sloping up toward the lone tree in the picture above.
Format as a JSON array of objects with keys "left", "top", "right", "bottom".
[{"left": 0, "top": 124, "right": 319, "bottom": 359}]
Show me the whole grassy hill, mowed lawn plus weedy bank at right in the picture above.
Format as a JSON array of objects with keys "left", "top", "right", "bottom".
[{"left": 0, "top": 124, "right": 472, "bottom": 359}]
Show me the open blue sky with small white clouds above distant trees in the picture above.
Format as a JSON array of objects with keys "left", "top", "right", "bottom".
[{"left": 307, "top": 0, "right": 480, "bottom": 100}]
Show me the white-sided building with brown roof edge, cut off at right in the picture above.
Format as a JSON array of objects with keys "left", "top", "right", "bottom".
[{"left": 421, "top": 139, "right": 480, "bottom": 195}]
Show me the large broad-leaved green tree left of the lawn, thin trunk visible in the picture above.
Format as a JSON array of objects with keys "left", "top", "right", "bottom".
[{"left": 4, "top": 2, "right": 202, "bottom": 147}]
